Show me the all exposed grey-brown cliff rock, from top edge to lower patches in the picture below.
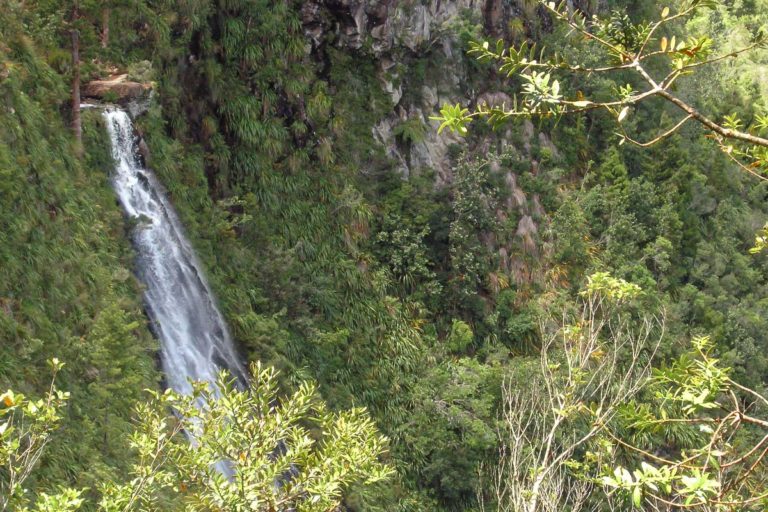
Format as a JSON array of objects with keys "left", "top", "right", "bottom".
[{"left": 302, "top": 0, "right": 584, "bottom": 284}]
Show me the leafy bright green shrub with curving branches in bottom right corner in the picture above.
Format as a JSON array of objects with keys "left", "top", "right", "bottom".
[{"left": 599, "top": 337, "right": 768, "bottom": 511}]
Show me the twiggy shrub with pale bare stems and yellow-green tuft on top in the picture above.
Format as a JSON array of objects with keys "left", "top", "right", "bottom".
[{"left": 480, "top": 273, "right": 664, "bottom": 512}]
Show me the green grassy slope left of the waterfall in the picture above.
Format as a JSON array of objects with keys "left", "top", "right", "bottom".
[{"left": 0, "top": 14, "right": 158, "bottom": 498}]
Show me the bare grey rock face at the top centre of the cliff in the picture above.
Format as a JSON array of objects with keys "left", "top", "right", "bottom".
[{"left": 301, "top": 0, "right": 576, "bottom": 186}]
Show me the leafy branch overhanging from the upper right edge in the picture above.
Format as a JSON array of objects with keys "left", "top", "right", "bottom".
[{"left": 434, "top": 0, "right": 768, "bottom": 179}]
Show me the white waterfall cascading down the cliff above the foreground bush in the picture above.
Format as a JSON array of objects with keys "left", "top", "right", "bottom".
[{"left": 104, "top": 108, "right": 246, "bottom": 394}]
